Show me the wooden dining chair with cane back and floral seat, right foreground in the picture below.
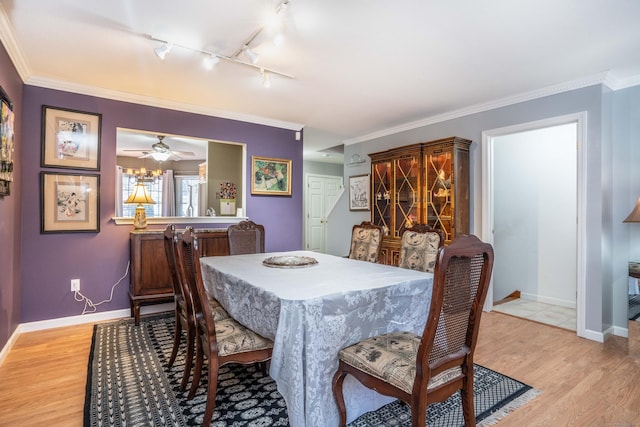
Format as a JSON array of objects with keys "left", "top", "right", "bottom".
[{"left": 333, "top": 235, "right": 493, "bottom": 427}]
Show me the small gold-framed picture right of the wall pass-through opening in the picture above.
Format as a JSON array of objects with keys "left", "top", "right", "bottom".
[{"left": 251, "top": 156, "right": 291, "bottom": 196}]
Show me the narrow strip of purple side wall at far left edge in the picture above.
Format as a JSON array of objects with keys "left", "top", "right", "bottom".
[{"left": 0, "top": 44, "right": 23, "bottom": 349}]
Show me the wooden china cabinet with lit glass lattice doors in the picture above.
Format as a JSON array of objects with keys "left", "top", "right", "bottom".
[{"left": 369, "top": 137, "right": 471, "bottom": 265}]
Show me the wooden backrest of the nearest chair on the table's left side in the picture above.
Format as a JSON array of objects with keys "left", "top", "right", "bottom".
[{"left": 178, "top": 227, "right": 216, "bottom": 343}]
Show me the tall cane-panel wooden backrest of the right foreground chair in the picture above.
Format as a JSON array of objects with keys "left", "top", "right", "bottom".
[{"left": 414, "top": 235, "right": 493, "bottom": 393}]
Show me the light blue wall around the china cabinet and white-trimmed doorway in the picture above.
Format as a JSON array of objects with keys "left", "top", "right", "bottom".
[{"left": 338, "top": 85, "right": 640, "bottom": 333}]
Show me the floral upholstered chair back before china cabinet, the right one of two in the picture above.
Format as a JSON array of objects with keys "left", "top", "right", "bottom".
[{"left": 398, "top": 224, "right": 444, "bottom": 273}]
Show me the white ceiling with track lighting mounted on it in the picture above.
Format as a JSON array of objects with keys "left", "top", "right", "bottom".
[{"left": 0, "top": 0, "right": 640, "bottom": 164}]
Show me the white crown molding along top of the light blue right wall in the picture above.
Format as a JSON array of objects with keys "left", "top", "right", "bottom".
[{"left": 343, "top": 72, "right": 640, "bottom": 145}]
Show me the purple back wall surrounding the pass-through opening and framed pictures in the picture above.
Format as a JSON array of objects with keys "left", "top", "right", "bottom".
[{"left": 17, "top": 86, "right": 303, "bottom": 324}]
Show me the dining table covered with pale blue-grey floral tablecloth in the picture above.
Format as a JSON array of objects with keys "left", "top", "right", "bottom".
[{"left": 200, "top": 251, "right": 433, "bottom": 427}]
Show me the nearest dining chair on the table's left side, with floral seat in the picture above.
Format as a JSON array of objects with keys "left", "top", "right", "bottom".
[{"left": 178, "top": 227, "right": 273, "bottom": 426}]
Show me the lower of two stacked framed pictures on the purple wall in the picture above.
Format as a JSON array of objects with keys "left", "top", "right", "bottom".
[{"left": 40, "top": 172, "right": 100, "bottom": 233}]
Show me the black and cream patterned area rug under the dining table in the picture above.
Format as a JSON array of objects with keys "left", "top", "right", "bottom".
[{"left": 84, "top": 315, "right": 538, "bottom": 427}]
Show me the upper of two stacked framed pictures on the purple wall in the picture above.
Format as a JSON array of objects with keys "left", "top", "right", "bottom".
[{"left": 40, "top": 105, "right": 102, "bottom": 170}]
